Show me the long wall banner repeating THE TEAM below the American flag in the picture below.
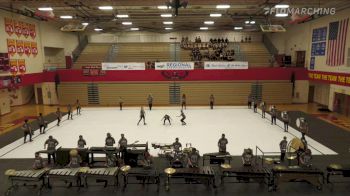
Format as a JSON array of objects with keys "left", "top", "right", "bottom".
[{"left": 308, "top": 71, "right": 350, "bottom": 86}]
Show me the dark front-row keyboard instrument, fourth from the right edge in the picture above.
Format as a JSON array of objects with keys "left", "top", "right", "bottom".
[{"left": 165, "top": 166, "right": 216, "bottom": 190}]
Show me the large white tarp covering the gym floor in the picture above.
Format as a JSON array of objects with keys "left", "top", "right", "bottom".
[{"left": 0, "top": 107, "right": 337, "bottom": 159}]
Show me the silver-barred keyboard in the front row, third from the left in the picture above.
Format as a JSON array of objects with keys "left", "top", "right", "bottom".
[{"left": 84, "top": 167, "right": 119, "bottom": 187}]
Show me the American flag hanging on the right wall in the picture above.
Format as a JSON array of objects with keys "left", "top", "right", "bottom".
[{"left": 326, "top": 18, "right": 349, "bottom": 66}]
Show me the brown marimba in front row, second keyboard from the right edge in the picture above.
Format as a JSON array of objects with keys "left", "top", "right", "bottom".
[{"left": 272, "top": 166, "right": 324, "bottom": 190}]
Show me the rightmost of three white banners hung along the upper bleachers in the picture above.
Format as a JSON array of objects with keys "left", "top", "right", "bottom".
[{"left": 204, "top": 61, "right": 248, "bottom": 69}]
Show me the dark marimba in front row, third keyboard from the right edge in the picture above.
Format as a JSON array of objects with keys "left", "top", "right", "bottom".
[{"left": 220, "top": 166, "right": 273, "bottom": 190}]
